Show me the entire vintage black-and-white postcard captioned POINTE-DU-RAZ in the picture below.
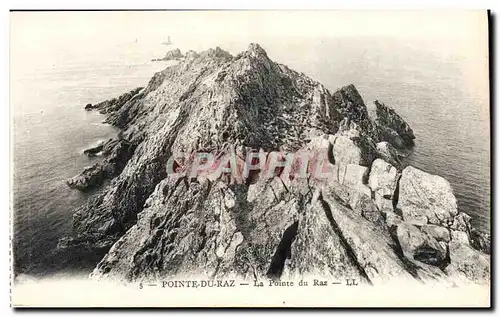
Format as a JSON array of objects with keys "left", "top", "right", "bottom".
[{"left": 9, "top": 9, "right": 492, "bottom": 308}]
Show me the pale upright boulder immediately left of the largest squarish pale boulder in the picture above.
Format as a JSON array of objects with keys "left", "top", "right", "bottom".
[{"left": 368, "top": 159, "right": 398, "bottom": 213}]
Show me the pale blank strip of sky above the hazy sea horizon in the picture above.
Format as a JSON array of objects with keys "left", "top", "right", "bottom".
[{"left": 11, "top": 10, "right": 487, "bottom": 45}]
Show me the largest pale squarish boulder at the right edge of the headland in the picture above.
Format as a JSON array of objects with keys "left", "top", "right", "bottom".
[{"left": 397, "top": 166, "right": 458, "bottom": 226}]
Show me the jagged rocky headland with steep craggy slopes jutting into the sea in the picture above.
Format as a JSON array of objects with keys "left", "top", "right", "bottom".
[{"left": 61, "top": 44, "right": 489, "bottom": 283}]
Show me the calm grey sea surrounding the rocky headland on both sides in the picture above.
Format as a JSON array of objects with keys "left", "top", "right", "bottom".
[{"left": 11, "top": 38, "right": 490, "bottom": 275}]
